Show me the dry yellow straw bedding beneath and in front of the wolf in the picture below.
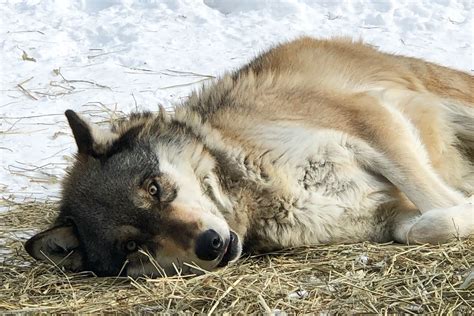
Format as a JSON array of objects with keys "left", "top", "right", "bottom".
[{"left": 0, "top": 202, "right": 474, "bottom": 314}]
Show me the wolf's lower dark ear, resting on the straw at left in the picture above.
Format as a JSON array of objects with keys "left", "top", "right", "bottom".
[{"left": 25, "top": 225, "right": 84, "bottom": 271}]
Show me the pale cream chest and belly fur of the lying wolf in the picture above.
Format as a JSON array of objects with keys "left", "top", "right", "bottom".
[{"left": 239, "top": 123, "right": 398, "bottom": 249}]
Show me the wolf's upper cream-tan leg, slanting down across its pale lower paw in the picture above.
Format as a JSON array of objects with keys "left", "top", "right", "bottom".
[{"left": 352, "top": 95, "right": 466, "bottom": 213}]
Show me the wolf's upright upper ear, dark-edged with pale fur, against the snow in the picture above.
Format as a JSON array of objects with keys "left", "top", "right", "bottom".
[{"left": 64, "top": 110, "right": 118, "bottom": 157}]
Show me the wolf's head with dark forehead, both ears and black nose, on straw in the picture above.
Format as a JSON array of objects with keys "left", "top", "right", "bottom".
[{"left": 25, "top": 110, "right": 242, "bottom": 276}]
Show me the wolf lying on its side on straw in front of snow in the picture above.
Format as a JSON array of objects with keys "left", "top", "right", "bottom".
[{"left": 25, "top": 38, "right": 474, "bottom": 277}]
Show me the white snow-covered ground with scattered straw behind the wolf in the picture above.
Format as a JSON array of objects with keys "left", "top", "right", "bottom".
[{"left": 0, "top": 0, "right": 474, "bottom": 206}]
